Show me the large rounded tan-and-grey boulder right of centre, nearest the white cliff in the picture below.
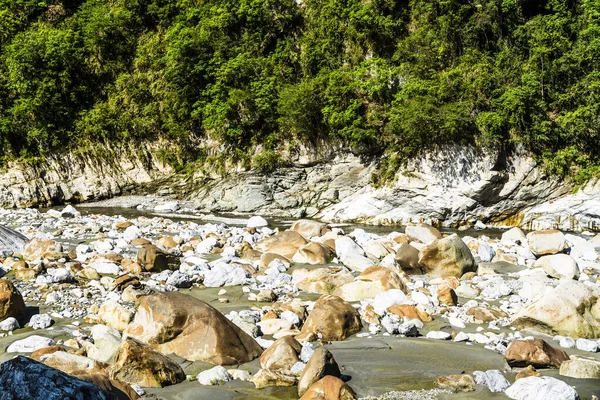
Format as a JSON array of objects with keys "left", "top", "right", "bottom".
[{"left": 419, "top": 234, "right": 476, "bottom": 278}]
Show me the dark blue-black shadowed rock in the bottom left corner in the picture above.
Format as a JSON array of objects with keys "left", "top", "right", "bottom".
[{"left": 0, "top": 356, "right": 115, "bottom": 400}]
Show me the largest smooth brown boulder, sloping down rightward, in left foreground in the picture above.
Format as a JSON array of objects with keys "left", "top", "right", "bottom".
[{"left": 125, "top": 292, "right": 262, "bottom": 365}]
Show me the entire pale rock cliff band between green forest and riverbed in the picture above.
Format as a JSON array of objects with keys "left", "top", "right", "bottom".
[{"left": 0, "top": 145, "right": 600, "bottom": 231}]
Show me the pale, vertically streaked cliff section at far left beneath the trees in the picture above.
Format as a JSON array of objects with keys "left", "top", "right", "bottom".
[{"left": 0, "top": 145, "right": 173, "bottom": 208}]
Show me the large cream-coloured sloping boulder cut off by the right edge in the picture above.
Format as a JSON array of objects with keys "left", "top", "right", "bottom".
[{"left": 513, "top": 280, "right": 600, "bottom": 339}]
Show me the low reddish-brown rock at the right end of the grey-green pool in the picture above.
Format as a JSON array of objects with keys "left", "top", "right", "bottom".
[{"left": 504, "top": 339, "right": 569, "bottom": 368}]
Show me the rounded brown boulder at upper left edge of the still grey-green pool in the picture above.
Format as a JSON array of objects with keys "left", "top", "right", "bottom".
[{"left": 302, "top": 295, "right": 362, "bottom": 340}]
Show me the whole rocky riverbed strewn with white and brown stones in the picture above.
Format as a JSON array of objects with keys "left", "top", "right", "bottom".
[{"left": 0, "top": 203, "right": 600, "bottom": 399}]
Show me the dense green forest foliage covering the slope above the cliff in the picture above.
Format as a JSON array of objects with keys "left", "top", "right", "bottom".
[{"left": 0, "top": 0, "right": 600, "bottom": 178}]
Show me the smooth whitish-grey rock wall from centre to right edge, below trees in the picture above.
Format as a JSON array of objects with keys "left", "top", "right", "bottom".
[{"left": 189, "top": 146, "right": 600, "bottom": 231}]
